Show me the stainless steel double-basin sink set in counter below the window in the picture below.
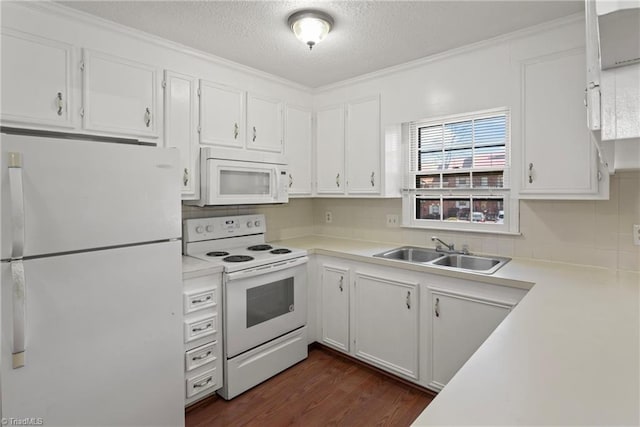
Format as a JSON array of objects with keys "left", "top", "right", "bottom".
[{"left": 374, "top": 246, "right": 511, "bottom": 274}]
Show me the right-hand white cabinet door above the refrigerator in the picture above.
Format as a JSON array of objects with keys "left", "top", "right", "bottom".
[{"left": 83, "top": 49, "right": 159, "bottom": 137}]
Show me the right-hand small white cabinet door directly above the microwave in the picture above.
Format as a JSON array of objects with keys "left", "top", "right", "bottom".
[{"left": 247, "top": 94, "right": 282, "bottom": 153}]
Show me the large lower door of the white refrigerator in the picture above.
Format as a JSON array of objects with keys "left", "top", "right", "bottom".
[{"left": 0, "top": 241, "right": 184, "bottom": 426}]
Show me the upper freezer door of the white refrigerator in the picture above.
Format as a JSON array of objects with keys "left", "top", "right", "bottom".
[{"left": 0, "top": 134, "right": 181, "bottom": 259}]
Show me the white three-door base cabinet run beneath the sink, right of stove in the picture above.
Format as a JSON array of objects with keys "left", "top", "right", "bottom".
[{"left": 310, "top": 255, "right": 527, "bottom": 391}]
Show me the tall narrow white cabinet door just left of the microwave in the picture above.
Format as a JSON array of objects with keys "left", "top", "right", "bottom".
[{"left": 163, "top": 71, "right": 200, "bottom": 200}]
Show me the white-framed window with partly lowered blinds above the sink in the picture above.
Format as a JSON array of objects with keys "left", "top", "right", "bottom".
[{"left": 403, "top": 109, "right": 517, "bottom": 232}]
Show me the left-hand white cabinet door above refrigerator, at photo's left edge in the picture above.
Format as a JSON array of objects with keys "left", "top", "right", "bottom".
[{"left": 2, "top": 28, "right": 73, "bottom": 128}]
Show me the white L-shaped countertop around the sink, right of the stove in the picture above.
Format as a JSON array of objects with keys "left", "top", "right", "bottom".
[{"left": 278, "top": 236, "right": 640, "bottom": 426}]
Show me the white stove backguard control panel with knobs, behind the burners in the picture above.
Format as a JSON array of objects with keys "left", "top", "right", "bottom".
[{"left": 182, "top": 214, "right": 267, "bottom": 243}]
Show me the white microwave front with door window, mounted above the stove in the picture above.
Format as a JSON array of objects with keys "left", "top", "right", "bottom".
[{"left": 203, "top": 159, "right": 288, "bottom": 205}]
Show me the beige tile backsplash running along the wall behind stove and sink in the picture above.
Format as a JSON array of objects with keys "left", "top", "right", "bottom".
[{"left": 182, "top": 171, "right": 640, "bottom": 271}]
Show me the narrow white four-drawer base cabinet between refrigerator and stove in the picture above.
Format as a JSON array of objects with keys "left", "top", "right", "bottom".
[{"left": 183, "top": 270, "right": 223, "bottom": 406}]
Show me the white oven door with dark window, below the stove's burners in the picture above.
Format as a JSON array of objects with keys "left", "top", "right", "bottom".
[{"left": 223, "top": 257, "right": 308, "bottom": 358}]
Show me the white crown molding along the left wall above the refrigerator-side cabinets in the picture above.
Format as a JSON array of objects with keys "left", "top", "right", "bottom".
[{"left": 15, "top": 0, "right": 313, "bottom": 94}]
